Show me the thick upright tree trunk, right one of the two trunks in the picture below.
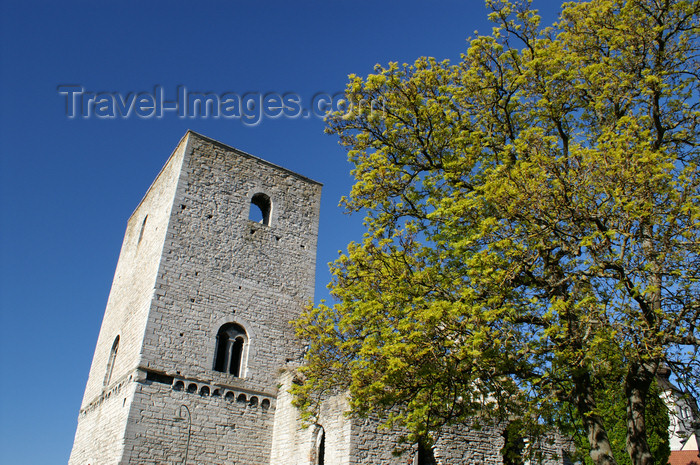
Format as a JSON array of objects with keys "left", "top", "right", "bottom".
[{"left": 625, "top": 363, "right": 663, "bottom": 465}]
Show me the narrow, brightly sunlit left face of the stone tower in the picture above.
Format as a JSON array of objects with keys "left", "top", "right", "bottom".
[{"left": 69, "top": 137, "right": 187, "bottom": 465}]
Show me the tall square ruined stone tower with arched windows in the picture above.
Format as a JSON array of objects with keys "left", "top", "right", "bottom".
[{"left": 69, "top": 132, "right": 321, "bottom": 465}]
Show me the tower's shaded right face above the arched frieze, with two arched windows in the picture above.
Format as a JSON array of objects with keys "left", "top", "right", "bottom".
[{"left": 142, "top": 134, "right": 321, "bottom": 392}]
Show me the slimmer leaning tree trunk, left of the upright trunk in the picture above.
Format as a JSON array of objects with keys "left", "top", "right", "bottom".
[{"left": 573, "top": 373, "right": 617, "bottom": 465}]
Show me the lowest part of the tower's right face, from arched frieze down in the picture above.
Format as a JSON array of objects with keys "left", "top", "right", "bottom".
[{"left": 122, "top": 377, "right": 275, "bottom": 465}]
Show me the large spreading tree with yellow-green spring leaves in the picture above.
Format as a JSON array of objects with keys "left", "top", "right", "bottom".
[{"left": 294, "top": 0, "right": 700, "bottom": 465}]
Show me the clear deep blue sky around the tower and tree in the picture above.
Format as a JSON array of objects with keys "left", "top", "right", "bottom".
[{"left": 0, "top": 0, "right": 559, "bottom": 465}]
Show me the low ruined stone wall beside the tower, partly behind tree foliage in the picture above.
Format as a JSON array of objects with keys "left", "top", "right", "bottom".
[{"left": 270, "top": 369, "right": 567, "bottom": 465}]
